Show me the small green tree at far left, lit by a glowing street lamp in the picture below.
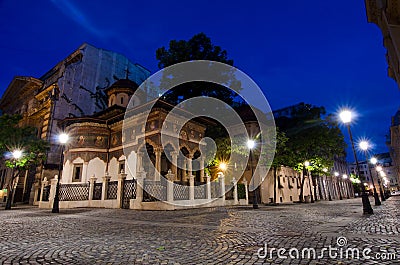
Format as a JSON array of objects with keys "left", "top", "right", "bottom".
[{"left": 0, "top": 114, "right": 48, "bottom": 209}]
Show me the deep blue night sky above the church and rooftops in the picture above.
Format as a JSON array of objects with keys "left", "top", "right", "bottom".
[{"left": 0, "top": 0, "right": 400, "bottom": 157}]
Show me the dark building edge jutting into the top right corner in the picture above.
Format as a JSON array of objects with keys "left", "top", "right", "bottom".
[{"left": 365, "top": 0, "right": 400, "bottom": 88}]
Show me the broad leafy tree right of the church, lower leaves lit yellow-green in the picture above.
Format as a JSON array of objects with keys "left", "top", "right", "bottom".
[{"left": 276, "top": 104, "right": 346, "bottom": 201}]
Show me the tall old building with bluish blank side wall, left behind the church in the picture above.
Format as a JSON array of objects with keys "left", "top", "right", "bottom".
[{"left": 0, "top": 43, "right": 152, "bottom": 204}]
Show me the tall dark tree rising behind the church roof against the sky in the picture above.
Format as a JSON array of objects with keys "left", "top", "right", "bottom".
[{"left": 156, "top": 33, "right": 241, "bottom": 105}]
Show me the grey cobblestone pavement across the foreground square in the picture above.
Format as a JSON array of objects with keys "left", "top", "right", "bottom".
[{"left": 0, "top": 196, "right": 400, "bottom": 264}]
